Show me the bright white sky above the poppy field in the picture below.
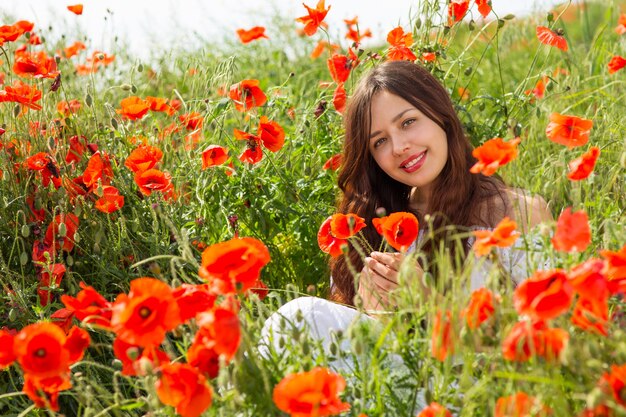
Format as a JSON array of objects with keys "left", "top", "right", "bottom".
[{"left": 0, "top": 0, "right": 562, "bottom": 56}]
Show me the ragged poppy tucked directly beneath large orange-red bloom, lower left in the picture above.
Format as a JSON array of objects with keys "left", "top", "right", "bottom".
[{"left": 113, "top": 337, "right": 170, "bottom": 376}]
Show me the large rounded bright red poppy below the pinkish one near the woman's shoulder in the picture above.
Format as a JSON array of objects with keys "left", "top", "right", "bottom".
[{"left": 513, "top": 269, "right": 574, "bottom": 320}]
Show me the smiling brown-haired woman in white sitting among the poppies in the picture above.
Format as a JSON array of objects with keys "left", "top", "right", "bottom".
[{"left": 263, "top": 61, "right": 552, "bottom": 366}]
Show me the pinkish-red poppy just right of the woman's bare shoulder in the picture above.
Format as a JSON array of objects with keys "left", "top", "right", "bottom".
[{"left": 551, "top": 207, "right": 591, "bottom": 252}]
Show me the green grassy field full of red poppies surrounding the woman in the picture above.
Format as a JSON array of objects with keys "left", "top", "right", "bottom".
[{"left": 0, "top": 0, "right": 626, "bottom": 417}]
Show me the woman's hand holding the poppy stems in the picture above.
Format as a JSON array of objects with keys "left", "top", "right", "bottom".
[{"left": 357, "top": 252, "right": 404, "bottom": 310}]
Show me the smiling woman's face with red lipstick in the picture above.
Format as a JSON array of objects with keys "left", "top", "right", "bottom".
[{"left": 369, "top": 91, "right": 448, "bottom": 195}]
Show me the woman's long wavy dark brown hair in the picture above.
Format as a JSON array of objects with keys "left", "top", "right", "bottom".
[{"left": 330, "top": 61, "right": 509, "bottom": 305}]
